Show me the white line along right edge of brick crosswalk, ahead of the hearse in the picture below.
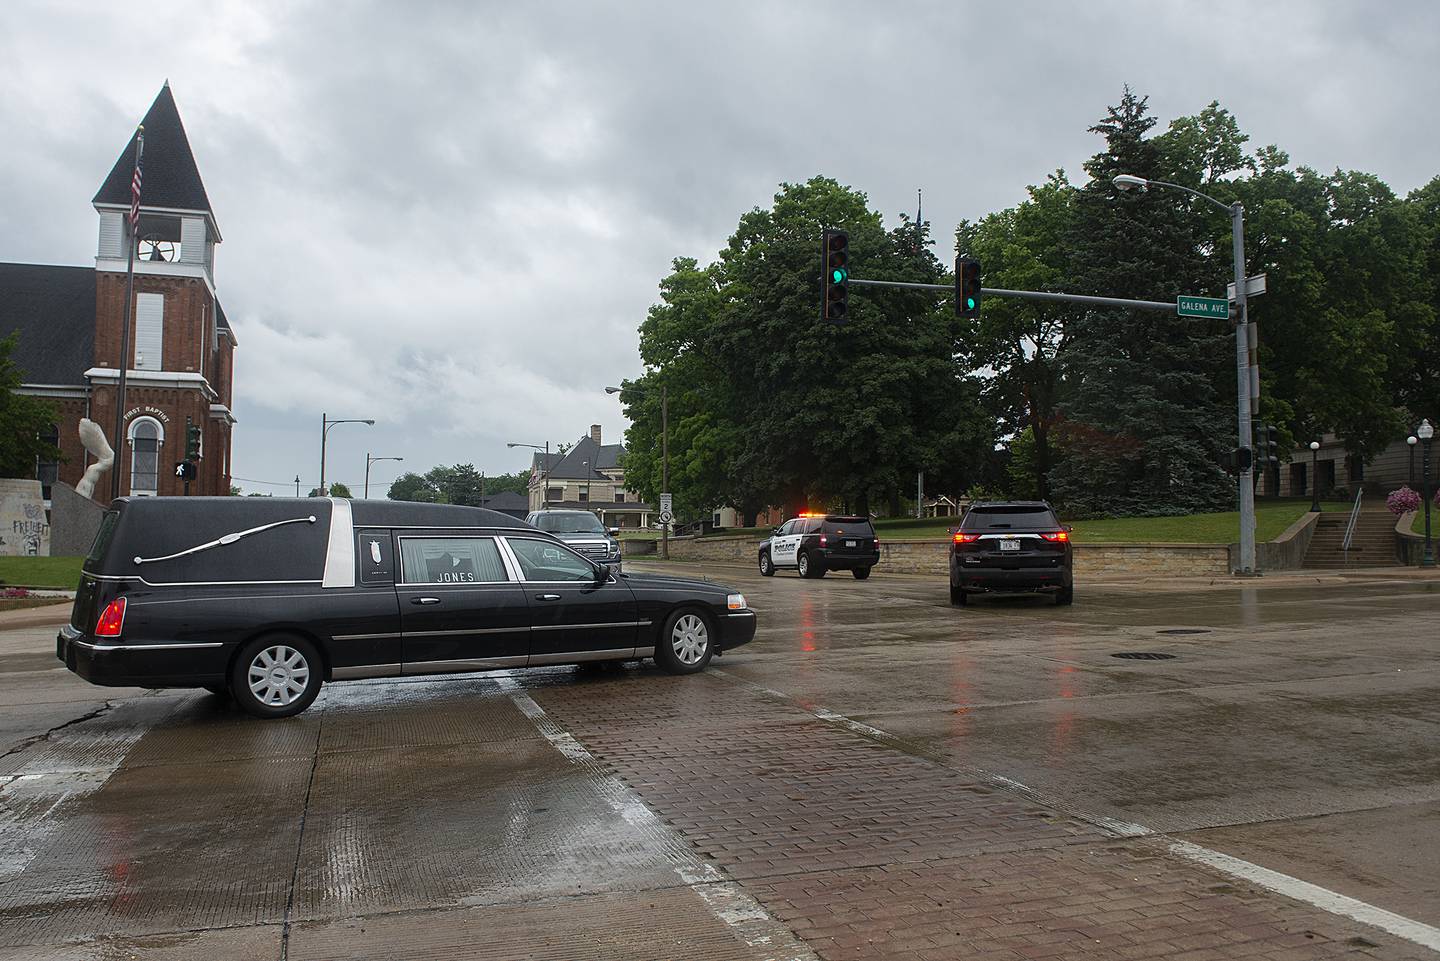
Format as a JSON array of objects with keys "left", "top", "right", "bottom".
[{"left": 710, "top": 667, "right": 1440, "bottom": 951}]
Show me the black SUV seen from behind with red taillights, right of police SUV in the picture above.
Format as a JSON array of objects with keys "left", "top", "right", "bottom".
[{"left": 950, "top": 500, "right": 1074, "bottom": 605}]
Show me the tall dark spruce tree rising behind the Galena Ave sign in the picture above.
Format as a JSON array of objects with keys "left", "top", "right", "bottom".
[{"left": 1053, "top": 88, "right": 1234, "bottom": 514}]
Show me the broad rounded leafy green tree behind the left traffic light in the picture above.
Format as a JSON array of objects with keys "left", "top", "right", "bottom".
[{"left": 624, "top": 177, "right": 989, "bottom": 522}]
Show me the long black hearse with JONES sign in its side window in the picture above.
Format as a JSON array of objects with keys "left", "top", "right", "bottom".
[{"left": 56, "top": 497, "right": 755, "bottom": 718}]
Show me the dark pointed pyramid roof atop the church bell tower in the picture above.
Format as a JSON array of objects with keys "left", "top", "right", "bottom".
[{"left": 92, "top": 81, "right": 215, "bottom": 230}]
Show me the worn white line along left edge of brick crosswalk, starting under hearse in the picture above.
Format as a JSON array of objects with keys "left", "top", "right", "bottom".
[{"left": 497, "top": 677, "right": 819, "bottom": 961}]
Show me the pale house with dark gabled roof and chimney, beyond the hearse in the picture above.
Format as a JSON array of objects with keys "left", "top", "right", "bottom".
[{"left": 530, "top": 424, "right": 654, "bottom": 529}]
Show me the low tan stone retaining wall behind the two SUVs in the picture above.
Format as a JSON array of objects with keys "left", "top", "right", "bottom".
[{"left": 670, "top": 537, "right": 1230, "bottom": 576}]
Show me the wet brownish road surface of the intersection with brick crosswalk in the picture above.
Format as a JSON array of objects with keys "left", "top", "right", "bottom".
[{"left": 0, "top": 565, "right": 1440, "bottom": 961}]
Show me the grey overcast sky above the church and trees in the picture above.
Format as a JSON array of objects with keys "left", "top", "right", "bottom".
[{"left": 0, "top": 0, "right": 1440, "bottom": 496}]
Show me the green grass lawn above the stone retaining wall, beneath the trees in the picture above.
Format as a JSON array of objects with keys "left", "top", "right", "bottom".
[{"left": 696, "top": 497, "right": 1351, "bottom": 543}]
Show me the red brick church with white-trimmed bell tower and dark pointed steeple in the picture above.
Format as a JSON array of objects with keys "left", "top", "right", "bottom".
[{"left": 0, "top": 84, "right": 236, "bottom": 503}]
